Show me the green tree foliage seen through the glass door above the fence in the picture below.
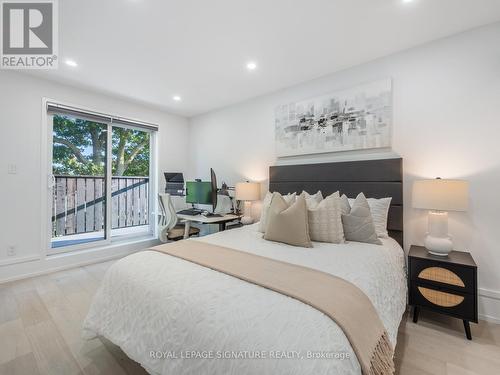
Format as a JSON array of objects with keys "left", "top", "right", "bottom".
[{"left": 53, "top": 115, "right": 150, "bottom": 177}]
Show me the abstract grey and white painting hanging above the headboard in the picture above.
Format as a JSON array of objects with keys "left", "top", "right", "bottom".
[{"left": 275, "top": 79, "right": 392, "bottom": 157}]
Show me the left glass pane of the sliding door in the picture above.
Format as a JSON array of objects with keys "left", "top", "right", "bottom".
[{"left": 52, "top": 114, "right": 107, "bottom": 248}]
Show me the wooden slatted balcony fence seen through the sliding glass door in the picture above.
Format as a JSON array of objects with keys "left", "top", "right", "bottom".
[{"left": 52, "top": 176, "right": 149, "bottom": 237}]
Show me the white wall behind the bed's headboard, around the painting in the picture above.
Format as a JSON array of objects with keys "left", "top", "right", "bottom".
[{"left": 190, "top": 23, "right": 500, "bottom": 322}]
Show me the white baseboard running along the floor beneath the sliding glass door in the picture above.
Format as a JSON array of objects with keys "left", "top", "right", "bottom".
[{"left": 0, "top": 239, "right": 158, "bottom": 284}]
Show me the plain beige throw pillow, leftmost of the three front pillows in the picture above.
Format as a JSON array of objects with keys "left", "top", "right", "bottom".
[{"left": 264, "top": 193, "right": 312, "bottom": 247}]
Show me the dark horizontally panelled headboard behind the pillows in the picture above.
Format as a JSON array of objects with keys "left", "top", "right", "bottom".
[{"left": 269, "top": 159, "right": 403, "bottom": 247}]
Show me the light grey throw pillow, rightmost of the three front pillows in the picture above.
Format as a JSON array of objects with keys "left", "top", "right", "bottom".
[{"left": 342, "top": 193, "right": 382, "bottom": 245}]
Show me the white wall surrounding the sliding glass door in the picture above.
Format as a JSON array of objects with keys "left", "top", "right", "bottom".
[{"left": 0, "top": 71, "right": 189, "bottom": 280}]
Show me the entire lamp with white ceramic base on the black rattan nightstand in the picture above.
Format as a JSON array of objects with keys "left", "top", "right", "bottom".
[{"left": 412, "top": 177, "right": 469, "bottom": 256}]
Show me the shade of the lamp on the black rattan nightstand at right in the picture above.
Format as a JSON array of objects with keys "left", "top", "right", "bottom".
[{"left": 412, "top": 178, "right": 469, "bottom": 211}]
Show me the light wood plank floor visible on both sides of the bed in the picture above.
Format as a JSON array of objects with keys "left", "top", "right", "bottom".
[{"left": 0, "top": 262, "right": 500, "bottom": 375}]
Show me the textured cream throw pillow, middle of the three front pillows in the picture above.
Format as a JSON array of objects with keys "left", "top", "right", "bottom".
[{"left": 308, "top": 192, "right": 344, "bottom": 243}]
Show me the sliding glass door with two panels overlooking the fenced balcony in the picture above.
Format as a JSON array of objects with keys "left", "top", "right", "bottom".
[{"left": 48, "top": 106, "right": 155, "bottom": 253}]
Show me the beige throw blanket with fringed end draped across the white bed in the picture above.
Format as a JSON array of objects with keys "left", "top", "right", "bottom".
[{"left": 151, "top": 241, "right": 394, "bottom": 375}]
